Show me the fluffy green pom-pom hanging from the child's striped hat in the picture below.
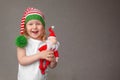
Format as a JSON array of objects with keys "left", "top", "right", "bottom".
[{"left": 16, "top": 35, "right": 28, "bottom": 48}]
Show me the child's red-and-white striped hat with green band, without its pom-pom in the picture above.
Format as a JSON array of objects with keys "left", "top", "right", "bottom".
[{"left": 20, "top": 8, "right": 45, "bottom": 35}]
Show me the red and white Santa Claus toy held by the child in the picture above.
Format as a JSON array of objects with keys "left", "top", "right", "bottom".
[{"left": 39, "top": 26, "right": 59, "bottom": 74}]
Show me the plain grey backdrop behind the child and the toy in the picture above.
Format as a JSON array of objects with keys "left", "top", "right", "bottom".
[{"left": 0, "top": 0, "right": 120, "bottom": 80}]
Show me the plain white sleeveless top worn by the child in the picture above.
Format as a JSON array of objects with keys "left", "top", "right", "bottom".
[{"left": 18, "top": 38, "right": 47, "bottom": 80}]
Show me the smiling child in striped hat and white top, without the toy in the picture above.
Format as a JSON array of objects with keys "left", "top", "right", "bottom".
[{"left": 16, "top": 8, "right": 57, "bottom": 80}]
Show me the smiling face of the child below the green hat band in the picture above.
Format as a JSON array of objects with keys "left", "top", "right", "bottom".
[{"left": 26, "top": 20, "right": 44, "bottom": 39}]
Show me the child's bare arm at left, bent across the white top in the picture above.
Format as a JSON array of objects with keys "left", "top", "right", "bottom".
[{"left": 17, "top": 47, "right": 53, "bottom": 66}]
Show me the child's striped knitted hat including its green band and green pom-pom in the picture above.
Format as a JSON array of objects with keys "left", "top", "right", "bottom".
[{"left": 16, "top": 8, "right": 45, "bottom": 48}]
